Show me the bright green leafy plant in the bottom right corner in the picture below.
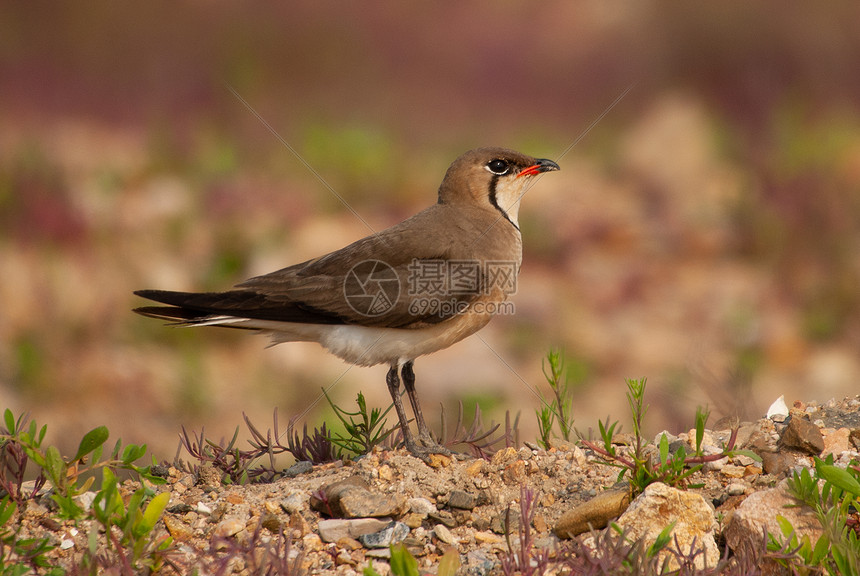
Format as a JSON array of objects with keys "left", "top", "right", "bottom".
[{"left": 768, "top": 455, "right": 860, "bottom": 574}]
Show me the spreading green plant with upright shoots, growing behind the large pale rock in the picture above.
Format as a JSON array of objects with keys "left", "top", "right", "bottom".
[{"left": 583, "top": 378, "right": 761, "bottom": 494}]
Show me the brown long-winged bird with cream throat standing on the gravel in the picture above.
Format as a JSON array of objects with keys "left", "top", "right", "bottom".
[{"left": 134, "top": 147, "right": 560, "bottom": 462}]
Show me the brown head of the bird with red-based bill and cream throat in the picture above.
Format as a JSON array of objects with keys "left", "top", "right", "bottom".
[{"left": 439, "top": 148, "right": 559, "bottom": 227}]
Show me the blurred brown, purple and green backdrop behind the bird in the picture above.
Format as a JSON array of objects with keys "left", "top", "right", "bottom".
[{"left": 0, "top": 1, "right": 860, "bottom": 458}]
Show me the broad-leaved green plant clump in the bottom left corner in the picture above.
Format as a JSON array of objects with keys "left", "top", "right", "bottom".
[{"left": 0, "top": 410, "right": 171, "bottom": 576}]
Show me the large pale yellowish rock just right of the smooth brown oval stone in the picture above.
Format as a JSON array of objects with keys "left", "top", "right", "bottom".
[{"left": 618, "top": 482, "right": 720, "bottom": 570}]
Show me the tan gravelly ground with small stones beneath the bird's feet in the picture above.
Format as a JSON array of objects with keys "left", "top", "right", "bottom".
[{"left": 8, "top": 397, "right": 860, "bottom": 574}]
